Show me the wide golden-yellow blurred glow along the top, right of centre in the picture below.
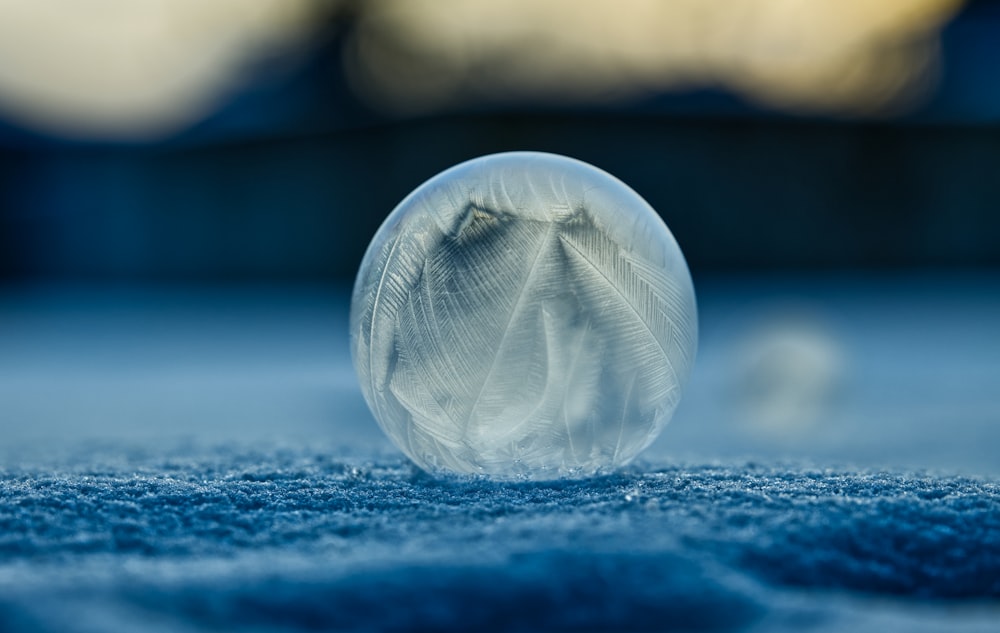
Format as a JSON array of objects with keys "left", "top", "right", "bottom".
[{"left": 352, "top": 0, "right": 961, "bottom": 114}]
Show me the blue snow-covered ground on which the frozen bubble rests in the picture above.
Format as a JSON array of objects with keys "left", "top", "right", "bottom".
[{"left": 0, "top": 276, "right": 1000, "bottom": 632}]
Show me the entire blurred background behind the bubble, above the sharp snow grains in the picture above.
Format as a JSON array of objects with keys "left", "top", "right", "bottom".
[{"left": 0, "top": 0, "right": 1000, "bottom": 474}]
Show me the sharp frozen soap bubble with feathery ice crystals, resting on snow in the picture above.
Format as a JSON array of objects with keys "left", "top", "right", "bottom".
[{"left": 351, "top": 152, "right": 698, "bottom": 479}]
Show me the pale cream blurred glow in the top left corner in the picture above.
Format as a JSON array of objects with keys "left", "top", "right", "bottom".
[{"left": 0, "top": 0, "right": 320, "bottom": 137}]
